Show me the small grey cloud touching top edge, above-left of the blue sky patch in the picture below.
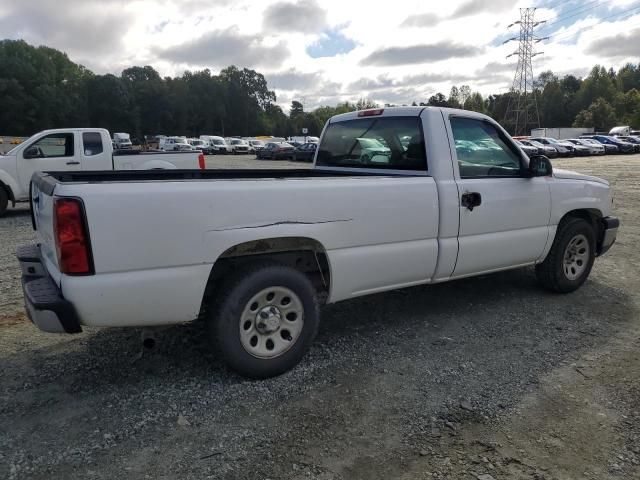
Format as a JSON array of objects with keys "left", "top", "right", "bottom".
[{"left": 263, "top": 0, "right": 328, "bottom": 33}]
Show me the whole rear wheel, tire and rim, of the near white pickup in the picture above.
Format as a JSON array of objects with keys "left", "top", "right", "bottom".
[{"left": 209, "top": 263, "right": 320, "bottom": 378}]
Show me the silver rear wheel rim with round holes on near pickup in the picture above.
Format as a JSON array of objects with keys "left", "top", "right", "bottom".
[{"left": 239, "top": 287, "right": 304, "bottom": 358}]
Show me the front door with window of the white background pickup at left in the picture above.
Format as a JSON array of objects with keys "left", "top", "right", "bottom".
[{"left": 17, "top": 132, "right": 80, "bottom": 192}]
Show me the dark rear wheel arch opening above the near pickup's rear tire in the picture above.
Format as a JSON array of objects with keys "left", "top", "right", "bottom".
[{"left": 199, "top": 237, "right": 331, "bottom": 318}]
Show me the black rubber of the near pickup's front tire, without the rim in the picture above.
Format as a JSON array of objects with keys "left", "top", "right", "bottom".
[{"left": 536, "top": 217, "right": 596, "bottom": 293}]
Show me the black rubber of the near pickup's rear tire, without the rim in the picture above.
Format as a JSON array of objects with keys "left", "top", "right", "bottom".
[{"left": 208, "top": 262, "right": 320, "bottom": 378}]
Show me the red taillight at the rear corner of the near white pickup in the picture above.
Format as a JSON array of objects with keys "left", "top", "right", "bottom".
[{"left": 53, "top": 198, "right": 93, "bottom": 275}]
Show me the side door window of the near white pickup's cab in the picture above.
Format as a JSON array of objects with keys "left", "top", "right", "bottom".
[{"left": 450, "top": 117, "right": 522, "bottom": 178}]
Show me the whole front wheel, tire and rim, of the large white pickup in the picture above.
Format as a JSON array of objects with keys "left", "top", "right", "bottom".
[{"left": 536, "top": 218, "right": 596, "bottom": 293}]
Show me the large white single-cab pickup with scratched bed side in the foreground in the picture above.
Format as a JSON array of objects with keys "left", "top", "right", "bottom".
[{"left": 17, "top": 107, "right": 619, "bottom": 377}]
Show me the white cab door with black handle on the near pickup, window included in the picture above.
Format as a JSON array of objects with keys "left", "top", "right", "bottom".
[{"left": 450, "top": 116, "right": 551, "bottom": 277}]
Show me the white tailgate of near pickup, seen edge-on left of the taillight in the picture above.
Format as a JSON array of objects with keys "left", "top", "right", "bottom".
[{"left": 30, "top": 173, "right": 60, "bottom": 286}]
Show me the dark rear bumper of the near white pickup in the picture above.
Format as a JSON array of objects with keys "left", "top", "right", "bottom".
[{"left": 16, "top": 245, "right": 82, "bottom": 333}]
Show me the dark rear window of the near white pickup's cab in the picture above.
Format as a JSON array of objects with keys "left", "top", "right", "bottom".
[{"left": 316, "top": 117, "right": 427, "bottom": 172}]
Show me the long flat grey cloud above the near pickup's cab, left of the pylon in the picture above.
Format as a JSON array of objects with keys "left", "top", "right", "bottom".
[{"left": 360, "top": 42, "right": 483, "bottom": 67}]
